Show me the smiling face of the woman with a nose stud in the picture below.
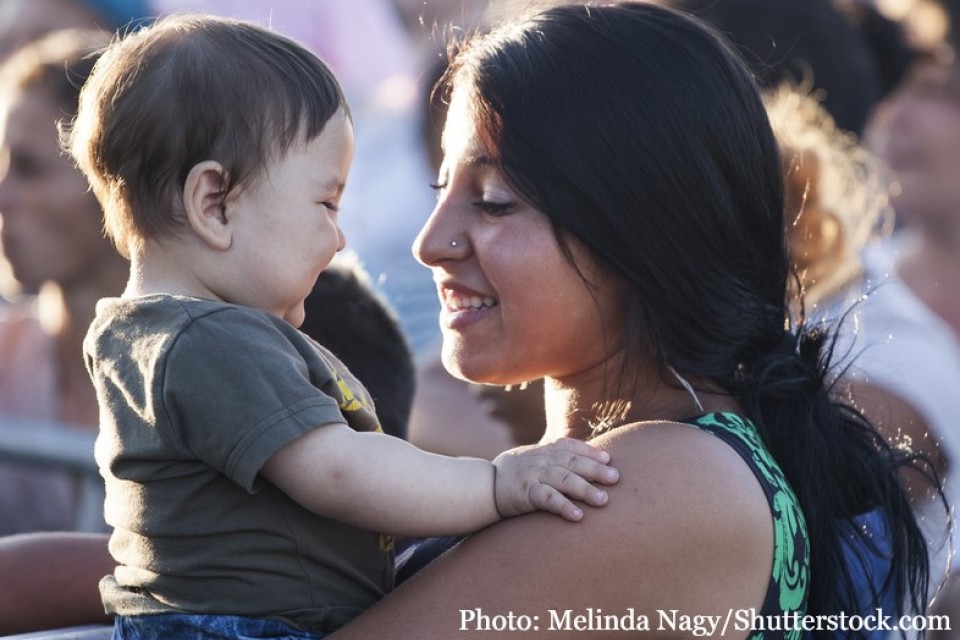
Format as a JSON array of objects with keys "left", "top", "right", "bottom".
[{"left": 414, "top": 92, "right": 624, "bottom": 385}]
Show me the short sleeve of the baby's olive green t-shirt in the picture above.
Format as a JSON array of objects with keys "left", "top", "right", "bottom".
[{"left": 162, "top": 309, "right": 345, "bottom": 492}]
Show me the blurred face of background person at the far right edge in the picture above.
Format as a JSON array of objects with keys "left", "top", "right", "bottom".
[{"left": 867, "top": 62, "right": 960, "bottom": 228}]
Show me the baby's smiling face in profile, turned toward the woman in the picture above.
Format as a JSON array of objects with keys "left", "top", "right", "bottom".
[{"left": 227, "top": 112, "right": 354, "bottom": 326}]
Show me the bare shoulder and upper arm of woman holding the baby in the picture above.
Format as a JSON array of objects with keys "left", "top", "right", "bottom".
[{"left": 333, "top": 425, "right": 773, "bottom": 640}]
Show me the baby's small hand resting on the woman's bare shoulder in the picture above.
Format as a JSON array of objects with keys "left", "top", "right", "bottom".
[{"left": 493, "top": 438, "right": 620, "bottom": 521}]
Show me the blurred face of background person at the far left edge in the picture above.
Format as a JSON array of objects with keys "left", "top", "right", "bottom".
[{"left": 0, "top": 89, "right": 115, "bottom": 288}]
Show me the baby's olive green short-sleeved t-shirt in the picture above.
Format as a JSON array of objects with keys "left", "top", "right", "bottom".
[{"left": 84, "top": 295, "right": 393, "bottom": 631}]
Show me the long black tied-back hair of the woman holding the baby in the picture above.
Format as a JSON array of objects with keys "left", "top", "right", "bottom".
[{"left": 446, "top": 3, "right": 929, "bottom": 636}]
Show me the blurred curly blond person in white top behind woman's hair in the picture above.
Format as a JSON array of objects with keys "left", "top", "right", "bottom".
[{"left": 766, "top": 86, "right": 960, "bottom": 589}]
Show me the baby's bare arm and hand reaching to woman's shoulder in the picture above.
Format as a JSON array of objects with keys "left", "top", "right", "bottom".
[{"left": 261, "top": 423, "right": 617, "bottom": 536}]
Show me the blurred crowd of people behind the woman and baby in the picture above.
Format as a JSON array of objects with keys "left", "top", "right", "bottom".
[{"left": 0, "top": 0, "right": 960, "bottom": 636}]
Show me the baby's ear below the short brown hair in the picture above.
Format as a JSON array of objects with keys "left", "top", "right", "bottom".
[{"left": 183, "top": 160, "right": 233, "bottom": 251}]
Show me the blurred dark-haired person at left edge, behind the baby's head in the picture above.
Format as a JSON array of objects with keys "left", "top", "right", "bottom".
[{"left": 0, "top": 30, "right": 127, "bottom": 534}]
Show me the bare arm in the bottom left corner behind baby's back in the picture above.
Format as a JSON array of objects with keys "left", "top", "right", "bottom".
[{"left": 0, "top": 533, "right": 116, "bottom": 635}]
